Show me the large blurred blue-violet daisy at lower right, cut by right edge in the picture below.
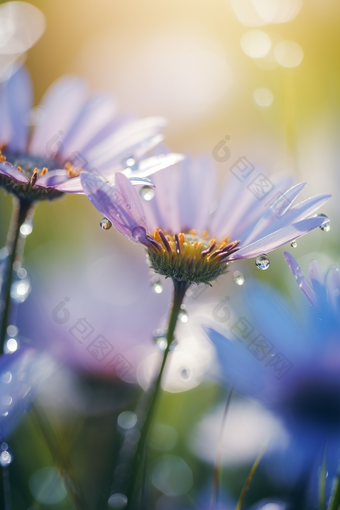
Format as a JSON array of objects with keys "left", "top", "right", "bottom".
[{"left": 205, "top": 253, "right": 340, "bottom": 508}]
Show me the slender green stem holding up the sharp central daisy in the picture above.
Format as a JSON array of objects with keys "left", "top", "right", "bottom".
[{"left": 126, "top": 280, "right": 190, "bottom": 510}]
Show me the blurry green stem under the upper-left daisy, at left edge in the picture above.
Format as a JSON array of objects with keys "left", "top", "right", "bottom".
[{"left": 0, "top": 198, "right": 32, "bottom": 354}]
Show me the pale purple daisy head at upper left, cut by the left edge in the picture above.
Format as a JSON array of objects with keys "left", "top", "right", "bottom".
[{"left": 0, "top": 68, "right": 182, "bottom": 202}]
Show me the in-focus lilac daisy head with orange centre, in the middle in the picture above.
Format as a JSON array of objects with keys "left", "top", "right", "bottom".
[{"left": 81, "top": 159, "right": 330, "bottom": 283}]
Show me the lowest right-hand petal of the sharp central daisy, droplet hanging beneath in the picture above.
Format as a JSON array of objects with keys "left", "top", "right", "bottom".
[{"left": 230, "top": 217, "right": 328, "bottom": 260}]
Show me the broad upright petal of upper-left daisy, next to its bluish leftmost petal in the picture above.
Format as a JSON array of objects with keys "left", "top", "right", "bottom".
[{"left": 29, "top": 76, "right": 87, "bottom": 158}]
